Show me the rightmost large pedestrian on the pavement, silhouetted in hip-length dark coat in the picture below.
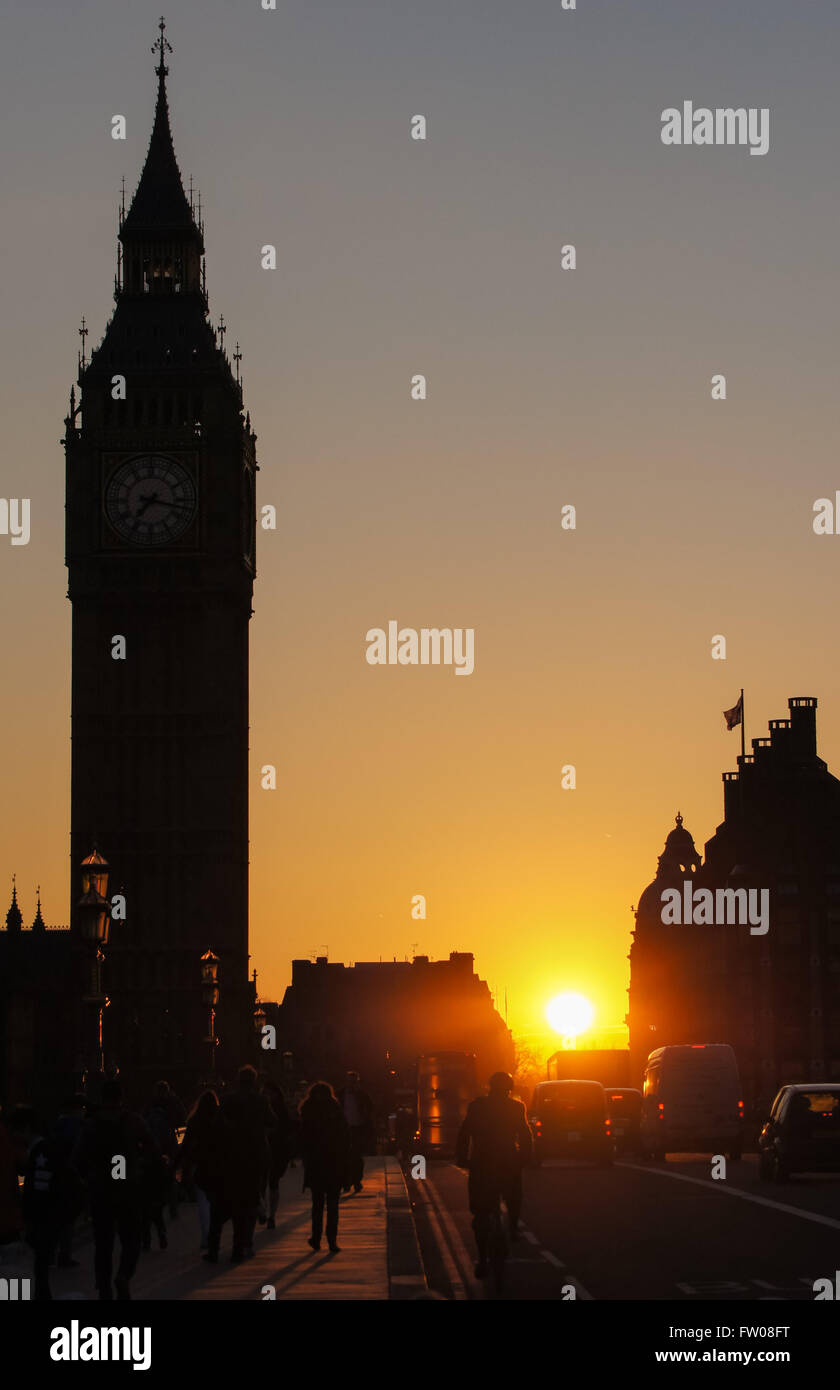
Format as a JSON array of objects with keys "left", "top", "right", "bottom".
[{"left": 300, "top": 1081, "right": 350, "bottom": 1255}]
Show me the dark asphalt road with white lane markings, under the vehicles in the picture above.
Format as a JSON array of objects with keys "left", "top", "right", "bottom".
[{"left": 407, "top": 1154, "right": 840, "bottom": 1302}]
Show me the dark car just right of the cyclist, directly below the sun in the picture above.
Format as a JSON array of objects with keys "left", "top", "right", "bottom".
[{"left": 528, "top": 1080, "right": 613, "bottom": 1168}]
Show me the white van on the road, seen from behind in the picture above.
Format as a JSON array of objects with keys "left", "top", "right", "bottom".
[{"left": 641, "top": 1043, "right": 744, "bottom": 1159}]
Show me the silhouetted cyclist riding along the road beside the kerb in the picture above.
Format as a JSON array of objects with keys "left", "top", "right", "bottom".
[{"left": 455, "top": 1072, "right": 534, "bottom": 1279}]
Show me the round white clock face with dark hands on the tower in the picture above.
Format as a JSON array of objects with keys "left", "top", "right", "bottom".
[{"left": 106, "top": 453, "right": 197, "bottom": 545}]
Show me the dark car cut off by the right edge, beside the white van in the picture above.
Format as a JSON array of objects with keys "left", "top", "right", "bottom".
[{"left": 758, "top": 1081, "right": 840, "bottom": 1183}]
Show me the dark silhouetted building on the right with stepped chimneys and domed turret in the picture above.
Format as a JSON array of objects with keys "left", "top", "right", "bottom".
[{"left": 627, "top": 698, "right": 840, "bottom": 1112}]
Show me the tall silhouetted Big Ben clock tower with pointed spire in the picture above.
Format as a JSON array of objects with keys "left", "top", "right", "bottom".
[{"left": 65, "top": 21, "right": 256, "bottom": 1090}]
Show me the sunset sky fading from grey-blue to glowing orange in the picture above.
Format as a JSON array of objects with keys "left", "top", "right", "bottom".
[{"left": 0, "top": 0, "right": 840, "bottom": 1034}]
